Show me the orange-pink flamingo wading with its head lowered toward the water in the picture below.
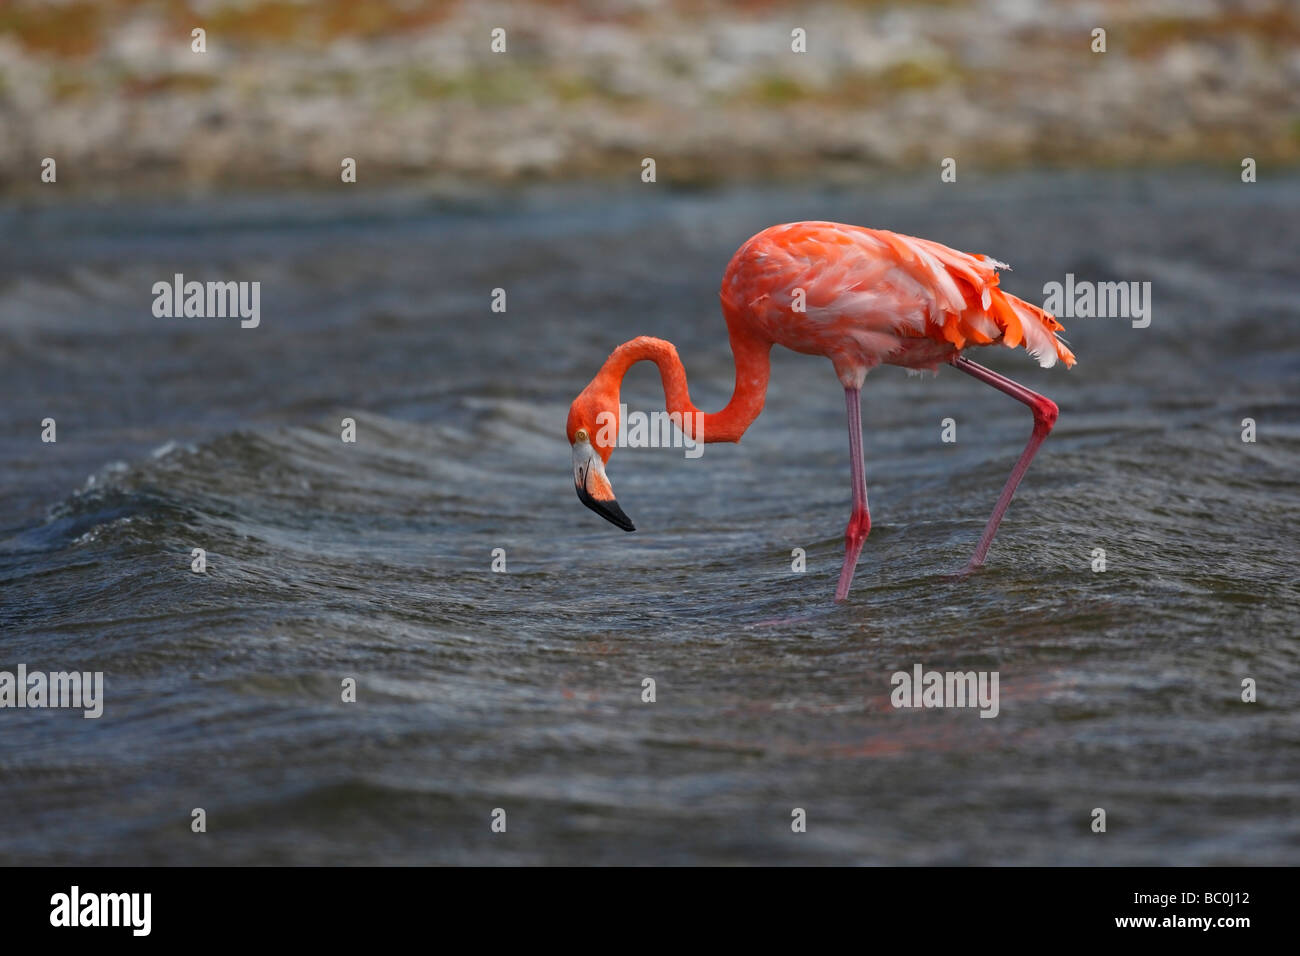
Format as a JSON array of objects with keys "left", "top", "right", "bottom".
[{"left": 566, "top": 221, "right": 1075, "bottom": 602}]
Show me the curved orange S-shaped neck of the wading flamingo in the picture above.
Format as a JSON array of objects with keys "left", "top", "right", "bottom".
[{"left": 598, "top": 323, "right": 772, "bottom": 442}]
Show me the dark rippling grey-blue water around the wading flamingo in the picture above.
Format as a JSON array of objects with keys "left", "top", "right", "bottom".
[{"left": 0, "top": 174, "right": 1300, "bottom": 864}]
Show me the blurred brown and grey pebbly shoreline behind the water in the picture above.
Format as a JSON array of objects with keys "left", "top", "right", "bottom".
[{"left": 0, "top": 0, "right": 1300, "bottom": 199}]
